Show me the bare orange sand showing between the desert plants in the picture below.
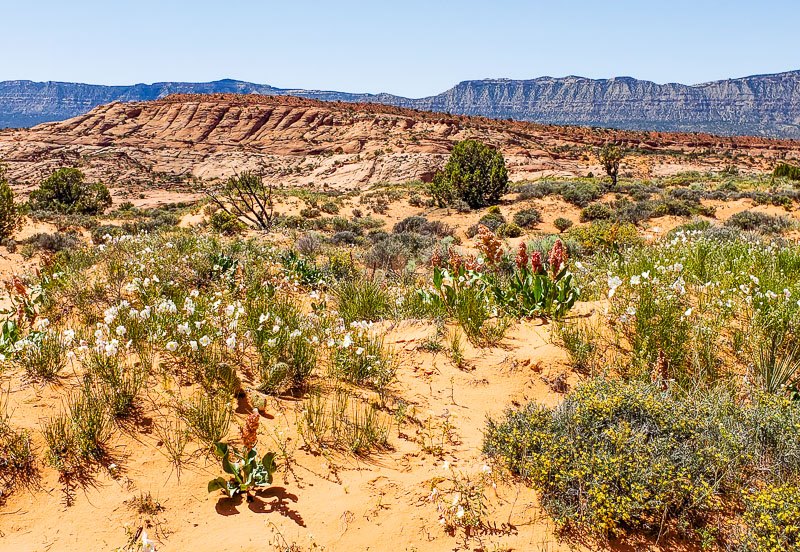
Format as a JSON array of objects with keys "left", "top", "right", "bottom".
[{"left": 0, "top": 183, "right": 796, "bottom": 552}]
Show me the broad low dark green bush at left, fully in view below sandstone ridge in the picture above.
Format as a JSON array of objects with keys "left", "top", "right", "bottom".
[{"left": 29, "top": 168, "right": 111, "bottom": 215}]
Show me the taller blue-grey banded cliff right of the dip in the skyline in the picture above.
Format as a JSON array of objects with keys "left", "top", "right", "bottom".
[{"left": 415, "top": 72, "right": 800, "bottom": 138}]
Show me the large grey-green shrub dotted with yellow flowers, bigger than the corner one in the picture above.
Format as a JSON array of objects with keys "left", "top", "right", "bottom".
[{"left": 484, "top": 380, "right": 753, "bottom": 536}]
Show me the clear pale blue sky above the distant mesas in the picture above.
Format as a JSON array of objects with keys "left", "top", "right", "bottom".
[{"left": 0, "top": 0, "right": 800, "bottom": 97}]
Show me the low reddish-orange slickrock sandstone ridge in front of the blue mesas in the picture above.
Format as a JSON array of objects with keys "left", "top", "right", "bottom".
[{"left": 0, "top": 94, "right": 800, "bottom": 195}]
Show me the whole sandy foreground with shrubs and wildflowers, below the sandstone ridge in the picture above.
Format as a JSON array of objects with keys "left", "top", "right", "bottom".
[{"left": 0, "top": 110, "right": 800, "bottom": 551}]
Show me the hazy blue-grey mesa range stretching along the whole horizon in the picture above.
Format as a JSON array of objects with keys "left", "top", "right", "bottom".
[{"left": 0, "top": 71, "right": 800, "bottom": 139}]
